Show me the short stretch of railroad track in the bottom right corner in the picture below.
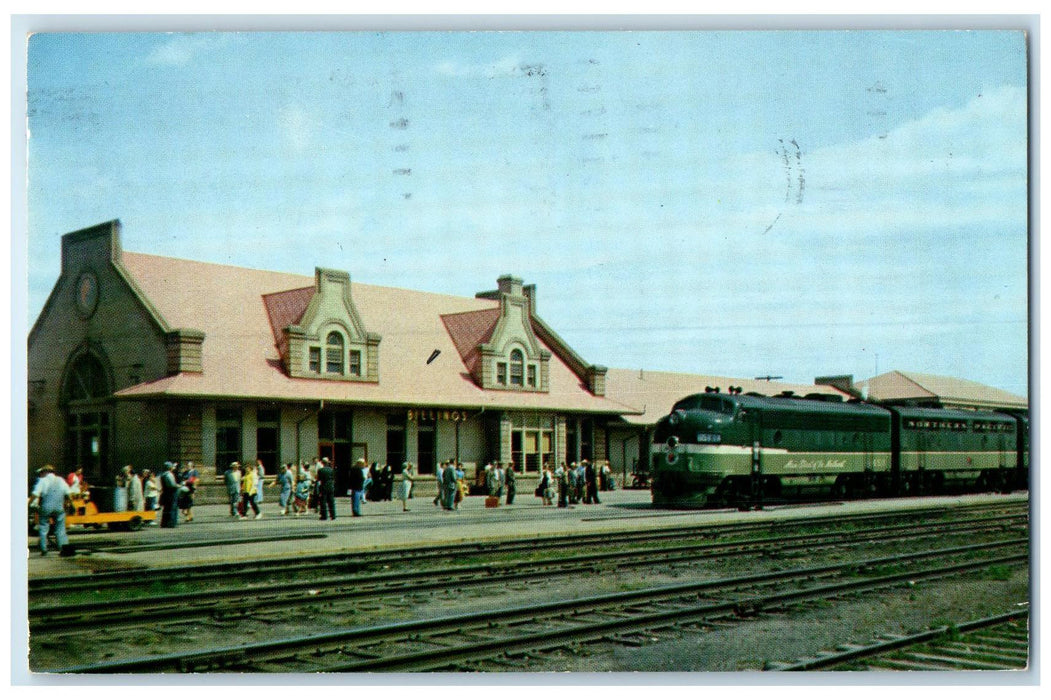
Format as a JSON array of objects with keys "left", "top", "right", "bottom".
[{"left": 767, "top": 605, "right": 1029, "bottom": 672}]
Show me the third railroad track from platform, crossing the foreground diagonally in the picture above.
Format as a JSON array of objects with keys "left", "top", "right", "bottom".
[{"left": 50, "top": 539, "right": 1028, "bottom": 674}]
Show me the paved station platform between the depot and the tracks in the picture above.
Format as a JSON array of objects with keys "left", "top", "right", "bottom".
[{"left": 26, "top": 490, "right": 1028, "bottom": 579}]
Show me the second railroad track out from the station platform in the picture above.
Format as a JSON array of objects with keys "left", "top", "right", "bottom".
[{"left": 28, "top": 506, "right": 1026, "bottom": 635}]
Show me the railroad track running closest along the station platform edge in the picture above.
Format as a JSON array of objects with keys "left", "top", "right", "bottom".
[{"left": 28, "top": 502, "right": 1028, "bottom": 600}]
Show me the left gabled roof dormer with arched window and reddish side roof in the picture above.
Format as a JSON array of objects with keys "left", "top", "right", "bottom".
[{"left": 265, "top": 268, "right": 380, "bottom": 382}]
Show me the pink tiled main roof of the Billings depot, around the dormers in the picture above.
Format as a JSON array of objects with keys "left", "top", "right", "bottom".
[{"left": 117, "top": 252, "right": 634, "bottom": 413}]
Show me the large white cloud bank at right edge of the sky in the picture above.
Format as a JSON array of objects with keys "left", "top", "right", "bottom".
[{"left": 700, "top": 87, "right": 1027, "bottom": 237}]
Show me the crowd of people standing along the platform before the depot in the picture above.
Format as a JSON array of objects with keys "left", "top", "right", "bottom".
[{"left": 29, "top": 457, "right": 616, "bottom": 554}]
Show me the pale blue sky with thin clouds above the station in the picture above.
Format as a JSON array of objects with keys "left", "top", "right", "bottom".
[{"left": 20, "top": 30, "right": 1029, "bottom": 396}]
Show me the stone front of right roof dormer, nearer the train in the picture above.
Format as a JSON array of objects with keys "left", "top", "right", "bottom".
[{"left": 475, "top": 274, "right": 551, "bottom": 392}]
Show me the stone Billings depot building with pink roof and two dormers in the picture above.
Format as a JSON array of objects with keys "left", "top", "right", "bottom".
[{"left": 28, "top": 221, "right": 641, "bottom": 488}]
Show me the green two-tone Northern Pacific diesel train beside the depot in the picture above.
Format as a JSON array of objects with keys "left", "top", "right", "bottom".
[{"left": 651, "top": 388, "right": 1029, "bottom": 509}]
